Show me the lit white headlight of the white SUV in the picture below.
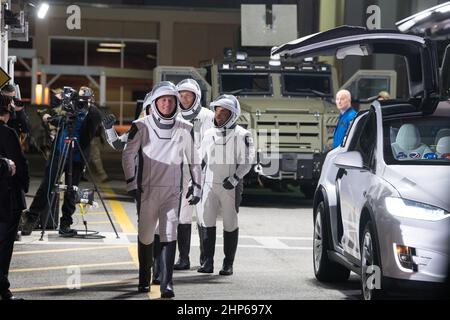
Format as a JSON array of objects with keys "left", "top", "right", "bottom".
[{"left": 385, "top": 197, "right": 450, "bottom": 221}]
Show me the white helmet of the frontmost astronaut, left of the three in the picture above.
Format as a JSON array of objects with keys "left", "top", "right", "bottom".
[{"left": 142, "top": 81, "right": 180, "bottom": 122}]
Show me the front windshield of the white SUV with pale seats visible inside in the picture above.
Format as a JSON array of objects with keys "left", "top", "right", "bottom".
[{"left": 383, "top": 116, "right": 450, "bottom": 165}]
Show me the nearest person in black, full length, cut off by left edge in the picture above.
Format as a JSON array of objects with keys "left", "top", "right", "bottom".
[{"left": 0, "top": 93, "right": 30, "bottom": 300}]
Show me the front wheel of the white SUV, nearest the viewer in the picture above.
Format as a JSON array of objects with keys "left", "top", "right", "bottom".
[{"left": 361, "top": 221, "right": 384, "bottom": 300}]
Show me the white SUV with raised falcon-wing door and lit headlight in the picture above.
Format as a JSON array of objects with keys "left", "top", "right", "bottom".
[{"left": 272, "top": 26, "right": 450, "bottom": 299}]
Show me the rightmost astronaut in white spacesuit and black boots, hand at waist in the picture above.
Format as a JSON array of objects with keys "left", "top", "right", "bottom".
[{"left": 197, "top": 94, "right": 255, "bottom": 275}]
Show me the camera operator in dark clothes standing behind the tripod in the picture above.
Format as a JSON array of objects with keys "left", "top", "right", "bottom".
[{"left": 22, "top": 87, "right": 101, "bottom": 237}]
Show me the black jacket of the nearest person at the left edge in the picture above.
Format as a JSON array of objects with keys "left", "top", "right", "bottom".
[{"left": 0, "top": 121, "right": 30, "bottom": 219}]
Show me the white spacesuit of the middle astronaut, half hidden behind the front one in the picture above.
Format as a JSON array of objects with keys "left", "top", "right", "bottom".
[{"left": 174, "top": 79, "right": 214, "bottom": 270}]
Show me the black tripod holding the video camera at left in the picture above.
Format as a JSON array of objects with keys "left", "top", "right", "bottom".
[{"left": 40, "top": 118, "right": 120, "bottom": 241}]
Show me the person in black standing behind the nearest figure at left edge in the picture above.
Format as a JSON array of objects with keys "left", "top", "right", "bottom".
[{"left": 1, "top": 84, "right": 30, "bottom": 150}]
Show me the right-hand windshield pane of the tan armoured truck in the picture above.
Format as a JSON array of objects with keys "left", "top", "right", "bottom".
[{"left": 281, "top": 74, "right": 332, "bottom": 96}]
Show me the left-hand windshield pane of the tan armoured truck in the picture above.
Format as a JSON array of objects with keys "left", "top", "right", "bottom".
[{"left": 220, "top": 73, "right": 272, "bottom": 95}]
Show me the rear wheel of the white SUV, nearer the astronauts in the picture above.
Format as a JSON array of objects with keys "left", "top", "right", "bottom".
[{"left": 313, "top": 202, "right": 350, "bottom": 282}]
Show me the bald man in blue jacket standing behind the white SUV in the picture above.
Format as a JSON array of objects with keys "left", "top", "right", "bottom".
[{"left": 333, "top": 90, "right": 357, "bottom": 149}]
